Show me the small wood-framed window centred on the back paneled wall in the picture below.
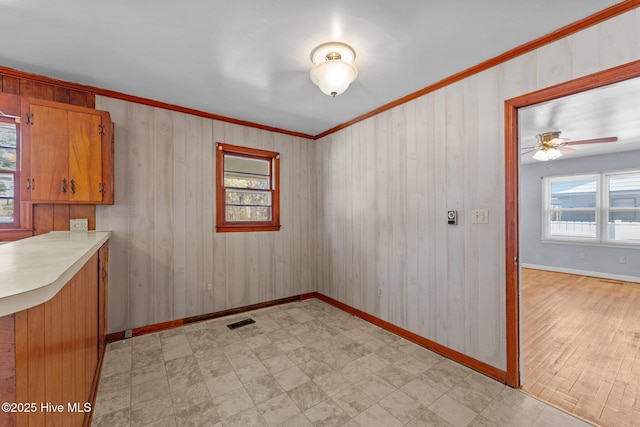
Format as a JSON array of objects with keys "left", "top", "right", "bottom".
[{"left": 216, "top": 143, "right": 280, "bottom": 232}]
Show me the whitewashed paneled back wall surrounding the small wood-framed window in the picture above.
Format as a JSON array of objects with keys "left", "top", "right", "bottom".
[{"left": 96, "top": 96, "right": 316, "bottom": 332}]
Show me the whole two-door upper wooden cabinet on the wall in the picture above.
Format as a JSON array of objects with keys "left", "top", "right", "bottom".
[{"left": 21, "top": 98, "right": 114, "bottom": 204}]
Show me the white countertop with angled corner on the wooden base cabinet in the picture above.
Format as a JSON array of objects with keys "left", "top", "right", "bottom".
[{"left": 0, "top": 231, "right": 111, "bottom": 316}]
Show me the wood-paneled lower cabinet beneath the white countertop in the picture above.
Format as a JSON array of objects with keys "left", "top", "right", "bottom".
[{"left": 0, "top": 244, "right": 108, "bottom": 427}]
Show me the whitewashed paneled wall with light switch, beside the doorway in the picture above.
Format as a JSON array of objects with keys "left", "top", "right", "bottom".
[{"left": 315, "top": 9, "right": 640, "bottom": 369}]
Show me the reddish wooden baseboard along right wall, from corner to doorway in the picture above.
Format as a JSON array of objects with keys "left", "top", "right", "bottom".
[{"left": 306, "top": 292, "right": 507, "bottom": 383}]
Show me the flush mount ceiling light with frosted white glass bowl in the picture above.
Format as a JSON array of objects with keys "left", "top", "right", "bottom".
[{"left": 310, "top": 42, "right": 358, "bottom": 96}]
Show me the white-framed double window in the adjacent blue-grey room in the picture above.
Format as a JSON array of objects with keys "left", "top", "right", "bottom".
[{"left": 543, "top": 171, "right": 640, "bottom": 245}]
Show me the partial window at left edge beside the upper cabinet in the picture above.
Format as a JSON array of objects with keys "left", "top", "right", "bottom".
[{"left": 0, "top": 117, "right": 20, "bottom": 229}]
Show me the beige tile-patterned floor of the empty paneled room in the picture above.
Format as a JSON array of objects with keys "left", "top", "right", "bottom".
[{"left": 93, "top": 299, "right": 588, "bottom": 427}]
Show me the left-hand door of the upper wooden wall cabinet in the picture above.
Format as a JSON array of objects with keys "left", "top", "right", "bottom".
[{"left": 28, "top": 104, "right": 69, "bottom": 201}]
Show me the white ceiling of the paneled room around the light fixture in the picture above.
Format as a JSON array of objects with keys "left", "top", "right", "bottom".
[{"left": 0, "top": 0, "right": 619, "bottom": 135}]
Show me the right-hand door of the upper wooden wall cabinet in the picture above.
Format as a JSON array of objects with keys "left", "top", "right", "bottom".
[{"left": 67, "top": 111, "right": 103, "bottom": 202}]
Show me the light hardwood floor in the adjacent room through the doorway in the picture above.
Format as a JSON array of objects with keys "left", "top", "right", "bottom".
[{"left": 521, "top": 269, "right": 640, "bottom": 426}]
